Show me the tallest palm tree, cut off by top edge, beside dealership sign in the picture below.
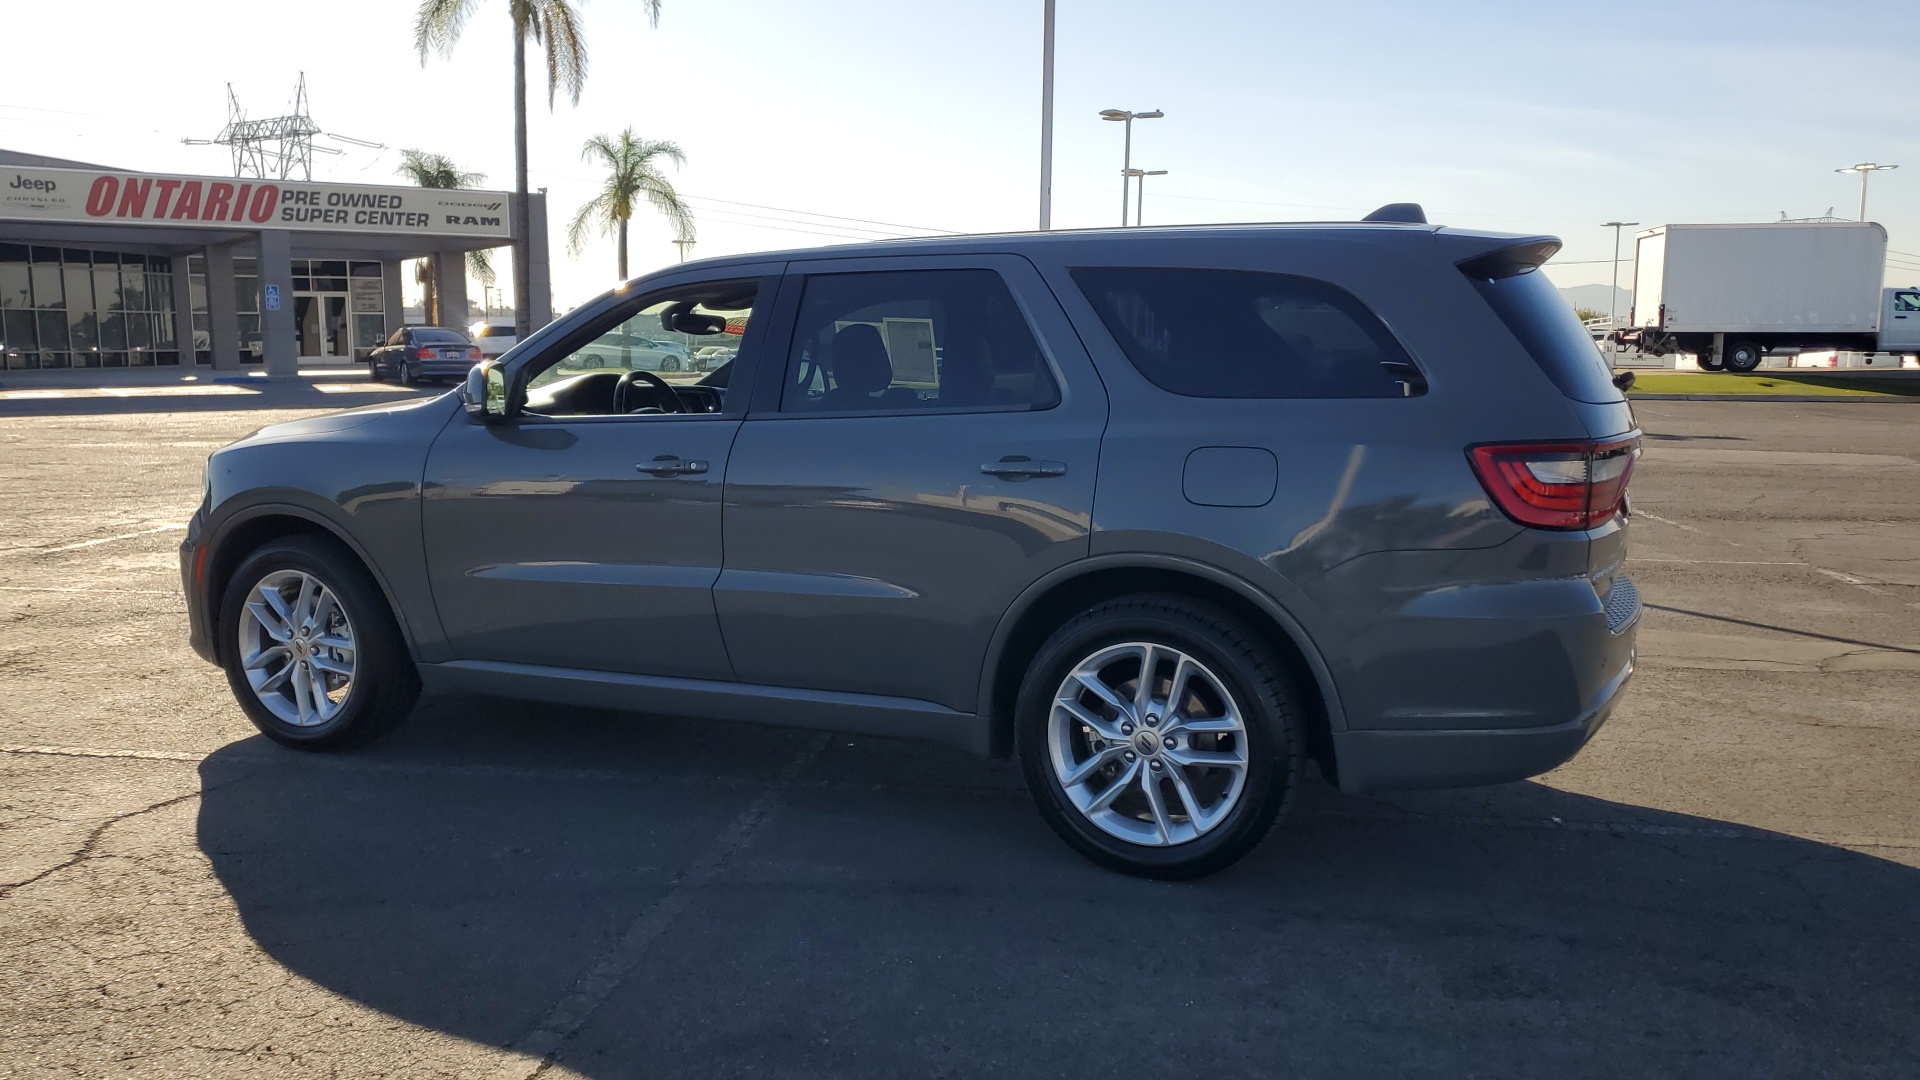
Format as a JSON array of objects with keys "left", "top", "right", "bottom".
[{"left": 413, "top": 0, "right": 660, "bottom": 340}]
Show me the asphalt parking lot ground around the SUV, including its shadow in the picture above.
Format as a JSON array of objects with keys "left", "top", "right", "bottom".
[{"left": 0, "top": 386, "right": 1920, "bottom": 1078}]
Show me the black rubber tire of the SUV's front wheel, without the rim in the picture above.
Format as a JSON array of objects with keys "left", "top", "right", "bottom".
[{"left": 215, "top": 536, "right": 420, "bottom": 749}]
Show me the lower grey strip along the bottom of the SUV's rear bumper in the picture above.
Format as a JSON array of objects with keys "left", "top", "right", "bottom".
[{"left": 1332, "top": 651, "right": 1636, "bottom": 794}]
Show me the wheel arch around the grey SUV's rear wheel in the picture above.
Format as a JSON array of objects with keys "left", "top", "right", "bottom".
[{"left": 979, "top": 555, "right": 1346, "bottom": 778}]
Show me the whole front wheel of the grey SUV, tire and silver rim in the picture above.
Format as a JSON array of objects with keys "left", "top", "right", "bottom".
[{"left": 221, "top": 536, "right": 420, "bottom": 749}]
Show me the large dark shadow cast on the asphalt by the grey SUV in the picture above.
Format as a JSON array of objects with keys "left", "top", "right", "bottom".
[{"left": 198, "top": 700, "right": 1920, "bottom": 1076}]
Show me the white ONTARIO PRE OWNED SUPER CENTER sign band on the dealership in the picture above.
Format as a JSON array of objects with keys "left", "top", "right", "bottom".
[{"left": 0, "top": 167, "right": 513, "bottom": 242}]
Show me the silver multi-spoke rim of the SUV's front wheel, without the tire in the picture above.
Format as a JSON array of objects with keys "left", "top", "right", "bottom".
[{"left": 238, "top": 569, "right": 357, "bottom": 728}]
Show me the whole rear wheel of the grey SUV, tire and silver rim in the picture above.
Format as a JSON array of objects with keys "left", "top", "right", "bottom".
[{"left": 1014, "top": 596, "right": 1302, "bottom": 878}]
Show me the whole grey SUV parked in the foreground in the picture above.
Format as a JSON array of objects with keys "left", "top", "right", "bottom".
[{"left": 180, "top": 208, "right": 1640, "bottom": 878}]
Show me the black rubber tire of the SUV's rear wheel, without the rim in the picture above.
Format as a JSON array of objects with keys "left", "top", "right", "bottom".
[{"left": 1014, "top": 594, "right": 1304, "bottom": 880}]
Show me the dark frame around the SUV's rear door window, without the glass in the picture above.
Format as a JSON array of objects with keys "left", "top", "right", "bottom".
[{"left": 753, "top": 254, "right": 1069, "bottom": 419}]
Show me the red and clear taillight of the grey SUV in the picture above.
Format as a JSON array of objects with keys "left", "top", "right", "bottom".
[{"left": 1467, "top": 434, "right": 1640, "bottom": 528}]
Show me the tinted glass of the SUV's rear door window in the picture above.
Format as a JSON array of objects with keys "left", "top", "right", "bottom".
[{"left": 780, "top": 269, "right": 1060, "bottom": 413}]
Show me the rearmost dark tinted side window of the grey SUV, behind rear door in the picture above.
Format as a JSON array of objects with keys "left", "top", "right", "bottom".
[{"left": 1071, "top": 267, "right": 1411, "bottom": 398}]
